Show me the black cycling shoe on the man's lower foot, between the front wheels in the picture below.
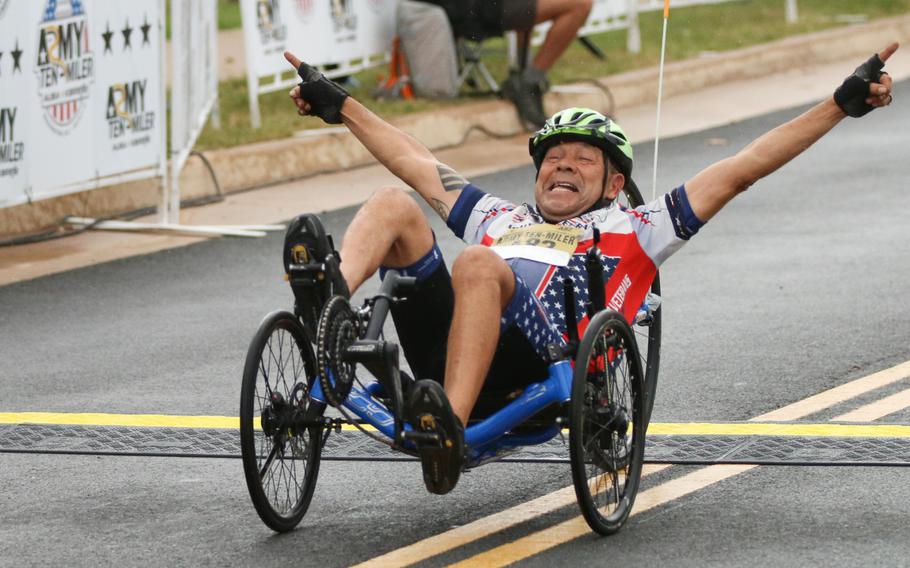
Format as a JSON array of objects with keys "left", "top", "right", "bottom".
[{"left": 407, "top": 379, "right": 465, "bottom": 495}]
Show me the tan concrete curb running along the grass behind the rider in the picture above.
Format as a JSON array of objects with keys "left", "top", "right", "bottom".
[{"left": 0, "top": 15, "right": 910, "bottom": 236}]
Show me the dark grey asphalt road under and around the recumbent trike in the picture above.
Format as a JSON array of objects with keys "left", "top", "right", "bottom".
[{"left": 0, "top": 90, "right": 910, "bottom": 566}]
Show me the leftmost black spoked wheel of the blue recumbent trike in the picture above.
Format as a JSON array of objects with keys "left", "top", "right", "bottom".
[{"left": 240, "top": 311, "right": 325, "bottom": 532}]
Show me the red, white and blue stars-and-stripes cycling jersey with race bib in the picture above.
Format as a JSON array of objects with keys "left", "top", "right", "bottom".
[{"left": 448, "top": 184, "right": 703, "bottom": 336}]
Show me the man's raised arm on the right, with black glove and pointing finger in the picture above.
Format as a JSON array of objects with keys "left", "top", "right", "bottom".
[{"left": 686, "top": 43, "right": 898, "bottom": 221}]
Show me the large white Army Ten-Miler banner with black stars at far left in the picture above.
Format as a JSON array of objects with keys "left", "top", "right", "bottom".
[{"left": 0, "top": 0, "right": 165, "bottom": 207}]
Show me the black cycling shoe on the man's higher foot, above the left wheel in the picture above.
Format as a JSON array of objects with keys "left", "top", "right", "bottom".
[{"left": 283, "top": 214, "right": 351, "bottom": 341}]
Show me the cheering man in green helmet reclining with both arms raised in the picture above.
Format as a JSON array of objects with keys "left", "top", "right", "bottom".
[{"left": 284, "top": 43, "right": 898, "bottom": 494}]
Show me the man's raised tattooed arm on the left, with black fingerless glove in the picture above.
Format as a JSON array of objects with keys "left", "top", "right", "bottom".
[{"left": 284, "top": 52, "right": 468, "bottom": 220}]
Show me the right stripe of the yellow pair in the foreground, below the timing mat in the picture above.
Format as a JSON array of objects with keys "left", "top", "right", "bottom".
[{"left": 451, "top": 465, "right": 758, "bottom": 568}]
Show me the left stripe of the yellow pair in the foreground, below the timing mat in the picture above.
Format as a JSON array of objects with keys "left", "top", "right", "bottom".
[{"left": 352, "top": 465, "right": 670, "bottom": 568}]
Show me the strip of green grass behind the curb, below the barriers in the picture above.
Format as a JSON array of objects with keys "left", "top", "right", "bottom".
[{"left": 197, "top": 0, "right": 910, "bottom": 150}]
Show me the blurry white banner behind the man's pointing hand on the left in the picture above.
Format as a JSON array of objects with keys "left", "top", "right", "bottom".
[{"left": 240, "top": 0, "right": 397, "bottom": 127}]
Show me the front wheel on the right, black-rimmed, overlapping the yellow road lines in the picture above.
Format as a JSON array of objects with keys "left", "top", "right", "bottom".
[{"left": 569, "top": 310, "right": 645, "bottom": 534}]
